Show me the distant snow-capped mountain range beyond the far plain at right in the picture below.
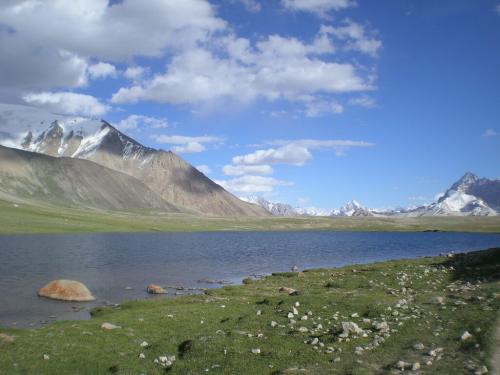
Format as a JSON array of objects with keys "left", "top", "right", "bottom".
[{"left": 241, "top": 172, "right": 500, "bottom": 217}]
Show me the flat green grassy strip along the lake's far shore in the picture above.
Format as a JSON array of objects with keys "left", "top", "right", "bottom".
[{"left": 0, "top": 200, "right": 500, "bottom": 234}]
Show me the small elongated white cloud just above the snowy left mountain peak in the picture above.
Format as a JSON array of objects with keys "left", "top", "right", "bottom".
[{"left": 23, "top": 92, "right": 110, "bottom": 117}]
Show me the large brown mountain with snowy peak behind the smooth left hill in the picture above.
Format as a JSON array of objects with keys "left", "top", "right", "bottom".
[{"left": 0, "top": 104, "right": 268, "bottom": 216}]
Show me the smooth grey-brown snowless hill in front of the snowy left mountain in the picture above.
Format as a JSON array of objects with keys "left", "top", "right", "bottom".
[{"left": 0, "top": 146, "right": 180, "bottom": 212}]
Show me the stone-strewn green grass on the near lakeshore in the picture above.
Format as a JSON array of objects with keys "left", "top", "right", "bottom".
[{"left": 0, "top": 249, "right": 500, "bottom": 375}]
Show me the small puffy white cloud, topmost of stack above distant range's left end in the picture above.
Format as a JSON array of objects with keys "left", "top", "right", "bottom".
[{"left": 232, "top": 144, "right": 312, "bottom": 166}]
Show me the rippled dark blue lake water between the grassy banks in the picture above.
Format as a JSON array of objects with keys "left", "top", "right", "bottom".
[{"left": 0, "top": 232, "right": 500, "bottom": 326}]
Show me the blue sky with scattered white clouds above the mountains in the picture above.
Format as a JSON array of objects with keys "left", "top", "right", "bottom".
[{"left": 0, "top": 0, "right": 500, "bottom": 208}]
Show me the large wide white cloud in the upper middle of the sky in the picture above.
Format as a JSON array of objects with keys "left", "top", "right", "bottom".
[{"left": 112, "top": 32, "right": 373, "bottom": 107}]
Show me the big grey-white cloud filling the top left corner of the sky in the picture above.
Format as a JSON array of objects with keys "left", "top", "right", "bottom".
[{"left": 0, "top": 0, "right": 226, "bottom": 97}]
